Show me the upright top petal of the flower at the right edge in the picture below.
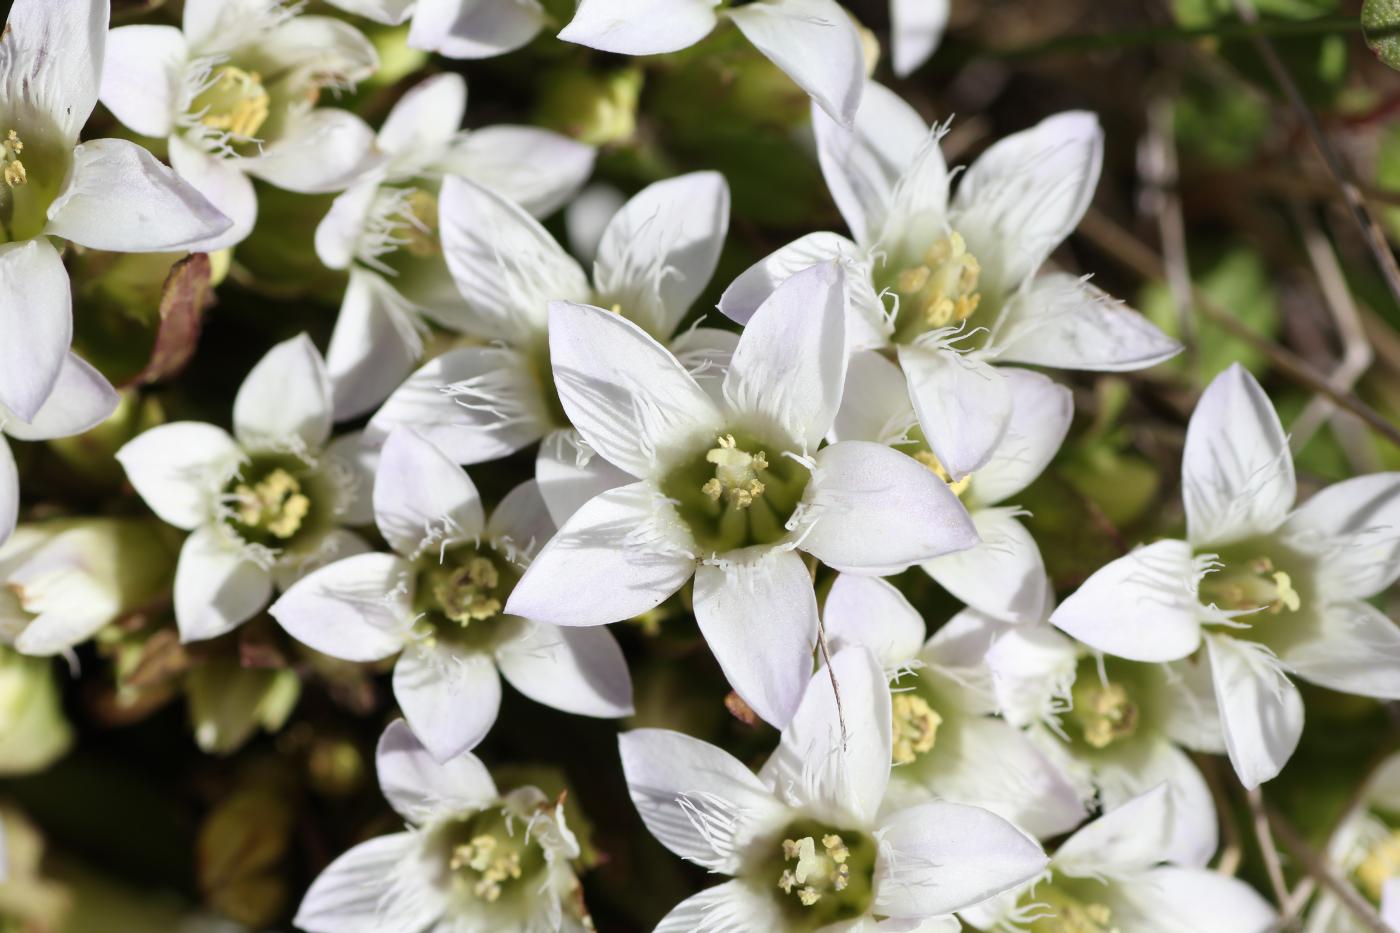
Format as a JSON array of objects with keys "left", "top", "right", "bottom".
[{"left": 1182, "top": 363, "right": 1296, "bottom": 548}]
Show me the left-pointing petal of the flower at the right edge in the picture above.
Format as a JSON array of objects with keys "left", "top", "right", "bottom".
[{"left": 1050, "top": 541, "right": 1201, "bottom": 661}]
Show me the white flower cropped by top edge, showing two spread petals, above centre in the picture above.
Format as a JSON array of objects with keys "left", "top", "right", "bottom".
[{"left": 559, "top": 0, "right": 865, "bottom": 125}]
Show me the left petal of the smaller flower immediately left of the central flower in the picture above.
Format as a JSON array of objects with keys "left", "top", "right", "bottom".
[{"left": 267, "top": 553, "right": 413, "bottom": 661}]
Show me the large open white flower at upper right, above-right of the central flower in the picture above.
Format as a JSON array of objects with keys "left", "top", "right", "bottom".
[{"left": 720, "top": 84, "right": 1180, "bottom": 479}]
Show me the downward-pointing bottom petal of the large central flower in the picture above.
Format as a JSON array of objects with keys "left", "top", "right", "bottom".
[{"left": 694, "top": 551, "right": 816, "bottom": 727}]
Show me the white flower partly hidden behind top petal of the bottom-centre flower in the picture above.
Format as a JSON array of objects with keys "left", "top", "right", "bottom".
[{"left": 822, "top": 574, "right": 1085, "bottom": 838}]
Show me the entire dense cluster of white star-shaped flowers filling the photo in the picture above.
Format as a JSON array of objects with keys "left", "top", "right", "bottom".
[{"left": 0, "top": 0, "right": 1400, "bottom": 933}]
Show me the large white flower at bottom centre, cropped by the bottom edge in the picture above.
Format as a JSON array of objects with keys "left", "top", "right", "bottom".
[{"left": 620, "top": 647, "right": 1046, "bottom": 933}]
